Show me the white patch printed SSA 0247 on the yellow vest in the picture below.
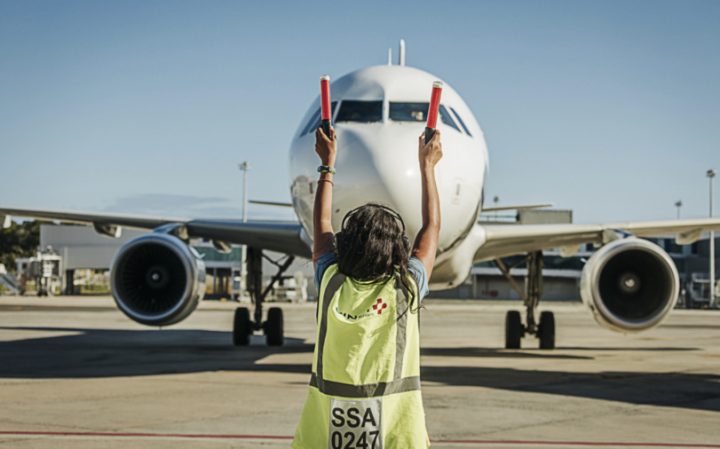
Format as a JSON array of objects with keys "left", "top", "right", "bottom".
[{"left": 328, "top": 398, "right": 383, "bottom": 449}]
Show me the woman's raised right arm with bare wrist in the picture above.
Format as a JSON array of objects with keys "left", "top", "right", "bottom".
[{"left": 412, "top": 130, "right": 442, "bottom": 279}]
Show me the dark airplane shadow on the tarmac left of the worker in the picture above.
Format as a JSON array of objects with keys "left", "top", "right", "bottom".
[{"left": 0, "top": 327, "right": 313, "bottom": 379}]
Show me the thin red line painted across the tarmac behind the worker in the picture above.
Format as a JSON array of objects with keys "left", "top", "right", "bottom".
[{"left": 0, "top": 430, "right": 720, "bottom": 449}]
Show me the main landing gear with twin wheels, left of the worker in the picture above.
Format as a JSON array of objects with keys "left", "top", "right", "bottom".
[{"left": 233, "top": 247, "right": 295, "bottom": 346}]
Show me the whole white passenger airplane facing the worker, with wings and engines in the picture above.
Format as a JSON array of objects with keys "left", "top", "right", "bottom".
[{"left": 0, "top": 42, "right": 720, "bottom": 349}]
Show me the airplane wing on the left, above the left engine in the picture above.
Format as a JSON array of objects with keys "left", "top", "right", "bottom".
[{"left": 0, "top": 207, "right": 312, "bottom": 258}]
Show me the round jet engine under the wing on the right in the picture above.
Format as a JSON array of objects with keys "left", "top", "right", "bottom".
[{"left": 580, "top": 237, "right": 680, "bottom": 332}]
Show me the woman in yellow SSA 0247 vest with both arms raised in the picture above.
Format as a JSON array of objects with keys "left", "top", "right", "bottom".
[{"left": 292, "top": 123, "right": 442, "bottom": 449}]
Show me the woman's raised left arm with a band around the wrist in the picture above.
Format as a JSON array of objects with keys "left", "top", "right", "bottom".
[{"left": 313, "top": 128, "right": 336, "bottom": 261}]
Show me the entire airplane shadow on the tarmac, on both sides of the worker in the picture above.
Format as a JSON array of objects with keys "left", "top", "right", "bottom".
[{"left": 0, "top": 327, "right": 720, "bottom": 412}]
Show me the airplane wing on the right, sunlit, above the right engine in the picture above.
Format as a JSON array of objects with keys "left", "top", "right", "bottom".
[{"left": 474, "top": 218, "right": 720, "bottom": 262}]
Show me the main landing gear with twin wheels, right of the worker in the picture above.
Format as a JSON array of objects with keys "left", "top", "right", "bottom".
[{"left": 495, "top": 251, "right": 555, "bottom": 349}]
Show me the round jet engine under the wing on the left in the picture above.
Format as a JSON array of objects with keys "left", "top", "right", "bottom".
[{"left": 110, "top": 233, "right": 205, "bottom": 326}]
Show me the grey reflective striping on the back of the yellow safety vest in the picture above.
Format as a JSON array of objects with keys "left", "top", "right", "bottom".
[{"left": 310, "top": 266, "right": 420, "bottom": 398}]
